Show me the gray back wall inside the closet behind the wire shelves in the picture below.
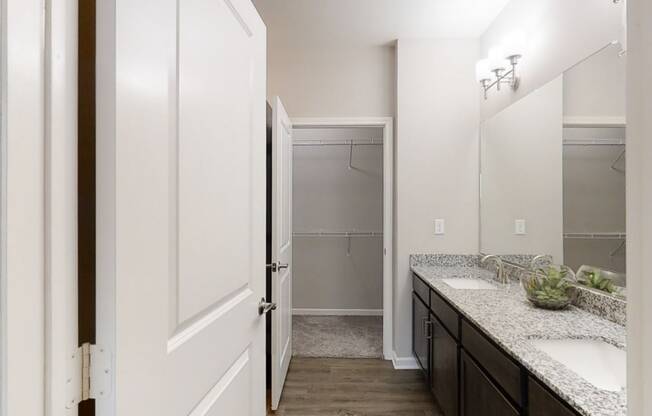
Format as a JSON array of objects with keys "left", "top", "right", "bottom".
[{"left": 292, "top": 128, "right": 383, "bottom": 310}]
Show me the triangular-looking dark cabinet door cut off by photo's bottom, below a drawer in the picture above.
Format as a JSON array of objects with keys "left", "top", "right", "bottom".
[{"left": 460, "top": 350, "right": 519, "bottom": 416}]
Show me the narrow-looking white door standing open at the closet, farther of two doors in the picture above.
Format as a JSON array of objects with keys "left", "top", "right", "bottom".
[{"left": 272, "top": 97, "right": 292, "bottom": 410}]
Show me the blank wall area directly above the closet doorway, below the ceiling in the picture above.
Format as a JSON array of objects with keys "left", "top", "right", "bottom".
[{"left": 267, "top": 43, "right": 395, "bottom": 118}]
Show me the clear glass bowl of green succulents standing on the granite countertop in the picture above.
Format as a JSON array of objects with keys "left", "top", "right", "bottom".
[{"left": 521, "top": 265, "right": 577, "bottom": 310}]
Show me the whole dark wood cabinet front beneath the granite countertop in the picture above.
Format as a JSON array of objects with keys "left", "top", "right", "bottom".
[{"left": 412, "top": 274, "right": 578, "bottom": 416}]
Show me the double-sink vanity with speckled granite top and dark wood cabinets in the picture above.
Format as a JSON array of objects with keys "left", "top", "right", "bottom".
[{"left": 412, "top": 256, "right": 626, "bottom": 416}]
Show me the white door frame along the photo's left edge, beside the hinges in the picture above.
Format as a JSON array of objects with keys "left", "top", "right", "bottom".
[{"left": 0, "top": 0, "right": 78, "bottom": 416}]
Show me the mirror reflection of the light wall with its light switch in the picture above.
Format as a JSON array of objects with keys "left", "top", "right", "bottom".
[{"left": 480, "top": 76, "right": 564, "bottom": 263}]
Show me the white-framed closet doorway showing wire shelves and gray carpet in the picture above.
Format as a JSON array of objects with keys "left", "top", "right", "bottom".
[{"left": 292, "top": 118, "right": 393, "bottom": 359}]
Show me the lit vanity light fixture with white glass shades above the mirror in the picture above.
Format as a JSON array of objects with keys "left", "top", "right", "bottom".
[{"left": 475, "top": 42, "right": 522, "bottom": 100}]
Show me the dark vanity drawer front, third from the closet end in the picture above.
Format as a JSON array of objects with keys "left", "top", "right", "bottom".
[{"left": 462, "top": 320, "right": 523, "bottom": 406}]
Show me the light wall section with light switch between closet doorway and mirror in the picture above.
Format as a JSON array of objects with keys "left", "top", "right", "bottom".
[{"left": 394, "top": 40, "right": 479, "bottom": 357}]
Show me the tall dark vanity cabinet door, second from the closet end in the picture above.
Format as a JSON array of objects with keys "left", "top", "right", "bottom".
[{"left": 430, "top": 315, "right": 458, "bottom": 416}]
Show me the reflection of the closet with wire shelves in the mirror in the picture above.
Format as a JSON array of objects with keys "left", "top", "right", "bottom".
[{"left": 563, "top": 127, "right": 626, "bottom": 278}]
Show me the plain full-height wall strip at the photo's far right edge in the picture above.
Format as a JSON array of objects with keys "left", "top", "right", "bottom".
[{"left": 627, "top": 0, "right": 652, "bottom": 416}]
